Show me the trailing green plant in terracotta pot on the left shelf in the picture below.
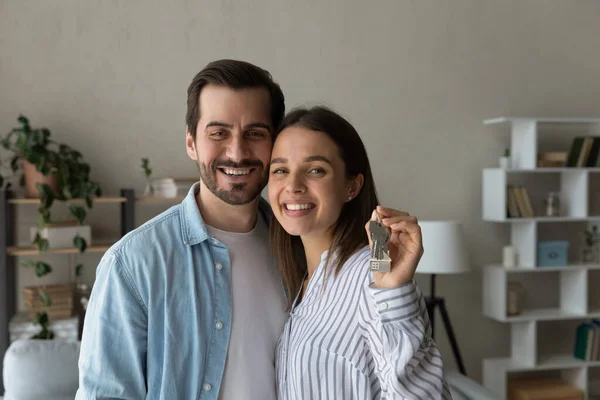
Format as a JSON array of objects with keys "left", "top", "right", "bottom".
[{"left": 0, "top": 115, "right": 101, "bottom": 339}]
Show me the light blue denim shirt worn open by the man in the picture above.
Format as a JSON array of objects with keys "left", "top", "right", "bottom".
[{"left": 76, "top": 184, "right": 271, "bottom": 400}]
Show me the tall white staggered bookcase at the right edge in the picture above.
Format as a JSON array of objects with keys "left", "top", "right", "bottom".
[{"left": 482, "top": 117, "right": 600, "bottom": 398}]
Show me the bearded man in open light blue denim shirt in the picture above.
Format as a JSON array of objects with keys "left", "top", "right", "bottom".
[{"left": 76, "top": 60, "right": 286, "bottom": 400}]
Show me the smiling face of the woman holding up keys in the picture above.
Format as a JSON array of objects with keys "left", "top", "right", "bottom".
[{"left": 269, "top": 126, "right": 353, "bottom": 236}]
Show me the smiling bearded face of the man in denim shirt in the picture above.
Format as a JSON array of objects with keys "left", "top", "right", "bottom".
[{"left": 186, "top": 85, "right": 273, "bottom": 205}]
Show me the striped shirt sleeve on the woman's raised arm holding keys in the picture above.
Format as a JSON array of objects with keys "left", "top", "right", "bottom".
[{"left": 360, "top": 281, "right": 452, "bottom": 400}]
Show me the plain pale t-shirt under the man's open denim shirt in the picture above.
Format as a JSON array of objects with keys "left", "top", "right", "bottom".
[{"left": 207, "top": 214, "right": 288, "bottom": 400}]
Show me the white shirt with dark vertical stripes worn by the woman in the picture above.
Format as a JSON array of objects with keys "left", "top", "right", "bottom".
[{"left": 276, "top": 247, "right": 452, "bottom": 400}]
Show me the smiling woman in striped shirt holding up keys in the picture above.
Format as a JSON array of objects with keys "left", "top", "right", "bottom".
[{"left": 269, "top": 107, "right": 451, "bottom": 400}]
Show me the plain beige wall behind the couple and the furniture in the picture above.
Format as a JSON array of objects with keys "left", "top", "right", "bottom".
[{"left": 0, "top": 0, "right": 600, "bottom": 379}]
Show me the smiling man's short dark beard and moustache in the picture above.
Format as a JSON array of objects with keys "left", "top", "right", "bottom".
[{"left": 198, "top": 159, "right": 269, "bottom": 206}]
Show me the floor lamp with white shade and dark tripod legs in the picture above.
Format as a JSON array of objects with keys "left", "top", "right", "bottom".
[{"left": 416, "top": 221, "right": 470, "bottom": 375}]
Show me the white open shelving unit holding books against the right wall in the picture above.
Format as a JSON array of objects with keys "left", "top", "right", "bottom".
[{"left": 482, "top": 117, "right": 600, "bottom": 399}]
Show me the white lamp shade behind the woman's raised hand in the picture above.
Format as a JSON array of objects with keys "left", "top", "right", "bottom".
[{"left": 416, "top": 221, "right": 471, "bottom": 274}]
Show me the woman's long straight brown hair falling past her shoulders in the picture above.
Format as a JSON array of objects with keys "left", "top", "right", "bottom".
[{"left": 271, "top": 106, "right": 379, "bottom": 306}]
